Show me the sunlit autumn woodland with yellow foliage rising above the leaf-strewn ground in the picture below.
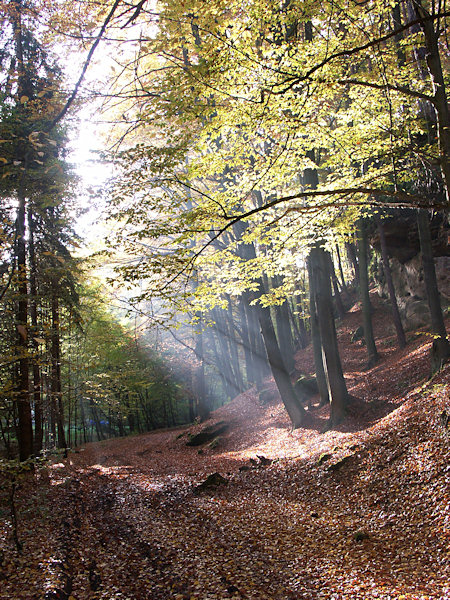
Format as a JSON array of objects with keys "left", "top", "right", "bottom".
[{"left": 0, "top": 0, "right": 450, "bottom": 461}]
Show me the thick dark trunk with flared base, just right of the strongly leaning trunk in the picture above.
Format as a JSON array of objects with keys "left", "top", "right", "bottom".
[{"left": 310, "top": 246, "right": 348, "bottom": 426}]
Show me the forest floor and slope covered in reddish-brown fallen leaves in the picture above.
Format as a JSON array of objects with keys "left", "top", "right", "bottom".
[{"left": 0, "top": 296, "right": 450, "bottom": 600}]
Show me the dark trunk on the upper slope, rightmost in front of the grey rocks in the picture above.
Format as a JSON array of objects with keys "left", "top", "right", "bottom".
[{"left": 417, "top": 209, "right": 450, "bottom": 372}]
